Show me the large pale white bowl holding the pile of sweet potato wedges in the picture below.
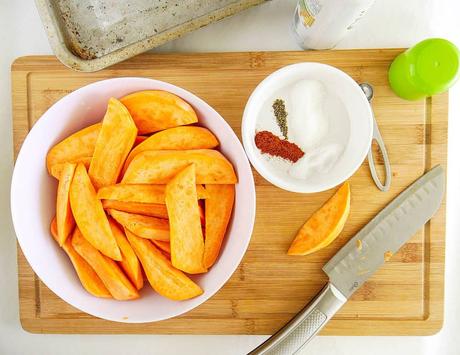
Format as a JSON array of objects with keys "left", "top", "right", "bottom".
[{"left": 11, "top": 78, "right": 255, "bottom": 323}]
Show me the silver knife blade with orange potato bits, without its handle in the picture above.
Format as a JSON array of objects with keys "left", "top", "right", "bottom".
[{"left": 323, "top": 166, "right": 444, "bottom": 298}]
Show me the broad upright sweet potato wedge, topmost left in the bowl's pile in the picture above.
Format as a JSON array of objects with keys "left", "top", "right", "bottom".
[{"left": 88, "top": 98, "right": 137, "bottom": 190}]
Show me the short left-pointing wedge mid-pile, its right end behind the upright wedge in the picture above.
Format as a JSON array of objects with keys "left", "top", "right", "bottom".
[{"left": 108, "top": 209, "right": 169, "bottom": 241}]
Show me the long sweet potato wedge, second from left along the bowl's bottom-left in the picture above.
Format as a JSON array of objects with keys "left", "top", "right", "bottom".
[{"left": 72, "top": 228, "right": 139, "bottom": 300}]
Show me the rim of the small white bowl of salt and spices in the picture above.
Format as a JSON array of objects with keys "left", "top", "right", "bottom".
[{"left": 241, "top": 62, "right": 374, "bottom": 193}]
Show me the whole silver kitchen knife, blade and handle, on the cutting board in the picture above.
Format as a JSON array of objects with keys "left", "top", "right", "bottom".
[{"left": 249, "top": 165, "right": 445, "bottom": 355}]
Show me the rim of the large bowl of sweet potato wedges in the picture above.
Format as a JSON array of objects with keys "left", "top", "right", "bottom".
[{"left": 10, "top": 76, "right": 256, "bottom": 323}]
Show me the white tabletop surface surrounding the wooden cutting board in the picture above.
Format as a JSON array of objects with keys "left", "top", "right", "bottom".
[{"left": 0, "top": 0, "right": 460, "bottom": 355}]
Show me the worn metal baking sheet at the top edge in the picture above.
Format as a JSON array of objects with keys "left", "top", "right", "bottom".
[{"left": 36, "top": 0, "right": 266, "bottom": 71}]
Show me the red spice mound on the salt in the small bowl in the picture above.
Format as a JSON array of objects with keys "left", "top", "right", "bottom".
[{"left": 254, "top": 131, "right": 305, "bottom": 163}]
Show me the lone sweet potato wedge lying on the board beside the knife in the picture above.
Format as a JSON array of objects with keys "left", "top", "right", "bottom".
[{"left": 288, "top": 182, "right": 350, "bottom": 255}]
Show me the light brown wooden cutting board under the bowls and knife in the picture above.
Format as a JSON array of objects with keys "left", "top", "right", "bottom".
[{"left": 12, "top": 49, "right": 447, "bottom": 335}]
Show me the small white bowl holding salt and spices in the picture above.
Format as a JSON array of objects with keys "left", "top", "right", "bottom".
[{"left": 242, "top": 63, "right": 373, "bottom": 193}]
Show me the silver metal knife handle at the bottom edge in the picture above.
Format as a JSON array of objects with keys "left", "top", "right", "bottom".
[{"left": 248, "top": 283, "right": 347, "bottom": 355}]
